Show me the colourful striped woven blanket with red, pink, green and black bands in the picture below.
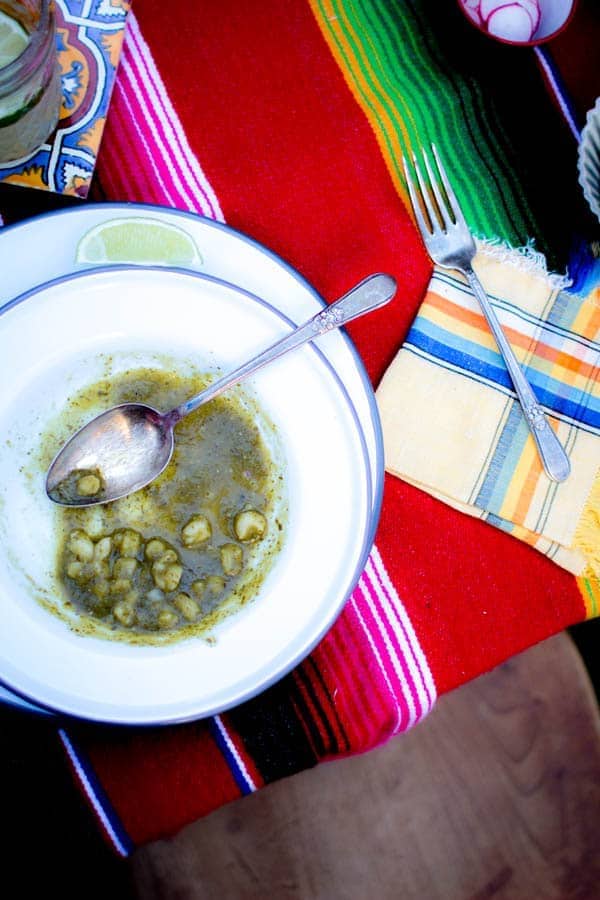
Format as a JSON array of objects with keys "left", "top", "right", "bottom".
[{"left": 2, "top": 0, "right": 589, "bottom": 855}]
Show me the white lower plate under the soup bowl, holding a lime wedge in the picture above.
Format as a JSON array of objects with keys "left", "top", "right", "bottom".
[{"left": 0, "top": 203, "right": 384, "bottom": 712}]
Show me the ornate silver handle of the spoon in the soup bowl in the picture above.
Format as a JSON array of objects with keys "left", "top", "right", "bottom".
[{"left": 167, "top": 274, "right": 396, "bottom": 424}]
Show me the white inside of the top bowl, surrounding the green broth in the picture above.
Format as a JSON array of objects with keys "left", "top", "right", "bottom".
[{"left": 0, "top": 267, "right": 373, "bottom": 724}]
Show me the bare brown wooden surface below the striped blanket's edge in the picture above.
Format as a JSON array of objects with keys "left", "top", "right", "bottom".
[{"left": 131, "top": 634, "right": 600, "bottom": 900}]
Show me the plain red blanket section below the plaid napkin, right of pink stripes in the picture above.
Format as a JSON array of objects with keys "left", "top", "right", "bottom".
[{"left": 378, "top": 475, "right": 585, "bottom": 694}]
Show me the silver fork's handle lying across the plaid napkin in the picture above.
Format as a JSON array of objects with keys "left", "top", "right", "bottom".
[{"left": 463, "top": 268, "right": 571, "bottom": 482}]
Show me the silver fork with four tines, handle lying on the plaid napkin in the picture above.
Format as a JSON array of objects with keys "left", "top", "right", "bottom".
[{"left": 402, "top": 144, "right": 571, "bottom": 482}]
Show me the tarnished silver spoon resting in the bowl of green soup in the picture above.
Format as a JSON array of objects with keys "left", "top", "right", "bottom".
[{"left": 46, "top": 274, "right": 396, "bottom": 506}]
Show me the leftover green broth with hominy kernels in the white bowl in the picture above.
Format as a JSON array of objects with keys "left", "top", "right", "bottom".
[{"left": 51, "top": 368, "right": 285, "bottom": 644}]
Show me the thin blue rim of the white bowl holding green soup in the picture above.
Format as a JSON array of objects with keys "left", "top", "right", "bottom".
[{"left": 0, "top": 264, "right": 383, "bottom": 727}]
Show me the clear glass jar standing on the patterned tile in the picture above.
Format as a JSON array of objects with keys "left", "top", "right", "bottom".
[{"left": 0, "top": 0, "right": 62, "bottom": 163}]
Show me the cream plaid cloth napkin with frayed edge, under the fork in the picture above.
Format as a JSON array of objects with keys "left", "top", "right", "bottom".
[{"left": 377, "top": 243, "right": 600, "bottom": 596}]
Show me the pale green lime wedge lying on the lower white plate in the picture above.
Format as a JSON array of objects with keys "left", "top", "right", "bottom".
[{"left": 75, "top": 217, "right": 202, "bottom": 268}]
